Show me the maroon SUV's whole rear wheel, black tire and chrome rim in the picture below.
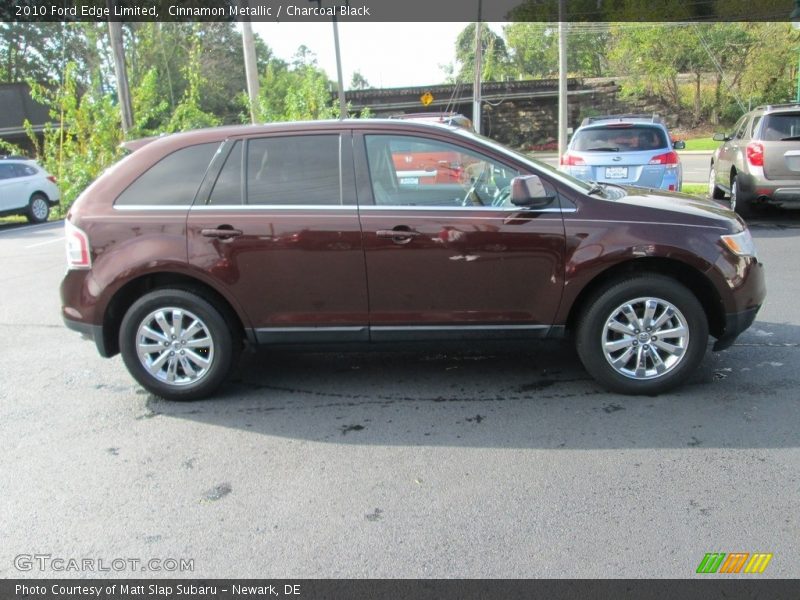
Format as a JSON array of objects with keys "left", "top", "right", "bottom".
[{"left": 119, "top": 288, "right": 241, "bottom": 400}]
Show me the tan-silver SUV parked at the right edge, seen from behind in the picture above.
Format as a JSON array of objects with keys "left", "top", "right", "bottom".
[{"left": 708, "top": 104, "right": 800, "bottom": 216}]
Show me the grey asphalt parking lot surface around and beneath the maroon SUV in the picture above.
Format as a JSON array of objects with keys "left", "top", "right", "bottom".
[{"left": 0, "top": 214, "right": 800, "bottom": 578}]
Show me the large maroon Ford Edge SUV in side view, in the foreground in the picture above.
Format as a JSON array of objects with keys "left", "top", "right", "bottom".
[{"left": 61, "top": 120, "right": 765, "bottom": 400}]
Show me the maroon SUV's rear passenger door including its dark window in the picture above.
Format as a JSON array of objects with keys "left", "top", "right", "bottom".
[{"left": 188, "top": 130, "right": 368, "bottom": 344}]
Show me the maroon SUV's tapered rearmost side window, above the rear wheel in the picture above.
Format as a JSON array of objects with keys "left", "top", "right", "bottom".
[{"left": 115, "top": 142, "right": 219, "bottom": 206}]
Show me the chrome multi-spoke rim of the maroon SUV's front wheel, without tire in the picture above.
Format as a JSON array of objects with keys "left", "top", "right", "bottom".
[{"left": 602, "top": 297, "right": 689, "bottom": 380}]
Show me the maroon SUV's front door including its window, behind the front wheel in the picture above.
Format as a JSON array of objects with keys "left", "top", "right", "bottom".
[{"left": 356, "top": 133, "right": 564, "bottom": 341}]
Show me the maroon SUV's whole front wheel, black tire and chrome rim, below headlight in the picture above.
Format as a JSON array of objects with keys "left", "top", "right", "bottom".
[{"left": 575, "top": 275, "right": 708, "bottom": 395}]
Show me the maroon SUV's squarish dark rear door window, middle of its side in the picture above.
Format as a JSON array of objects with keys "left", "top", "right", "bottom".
[{"left": 247, "top": 134, "right": 342, "bottom": 205}]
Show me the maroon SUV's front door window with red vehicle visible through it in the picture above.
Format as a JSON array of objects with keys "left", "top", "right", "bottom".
[{"left": 366, "top": 135, "right": 520, "bottom": 207}]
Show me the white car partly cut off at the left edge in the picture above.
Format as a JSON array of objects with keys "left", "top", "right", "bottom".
[{"left": 0, "top": 156, "right": 61, "bottom": 223}]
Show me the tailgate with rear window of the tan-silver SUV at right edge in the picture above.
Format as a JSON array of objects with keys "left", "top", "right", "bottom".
[{"left": 761, "top": 111, "right": 800, "bottom": 180}]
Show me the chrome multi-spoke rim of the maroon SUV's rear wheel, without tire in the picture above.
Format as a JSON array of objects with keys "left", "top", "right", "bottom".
[{"left": 136, "top": 307, "right": 214, "bottom": 386}]
